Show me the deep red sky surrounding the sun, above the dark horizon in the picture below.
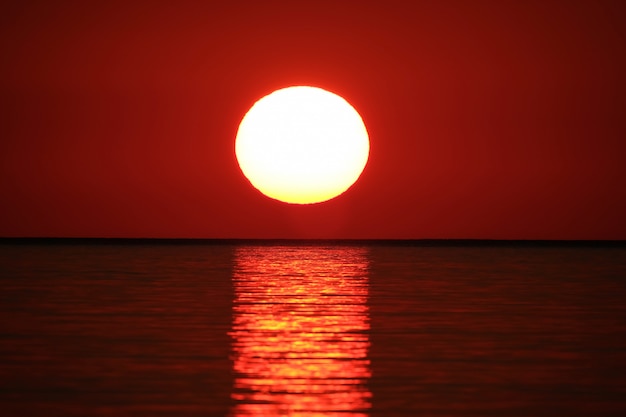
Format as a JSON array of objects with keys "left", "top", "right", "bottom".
[{"left": 0, "top": 0, "right": 626, "bottom": 239}]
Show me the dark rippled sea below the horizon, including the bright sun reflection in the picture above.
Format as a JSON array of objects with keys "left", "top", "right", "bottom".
[{"left": 0, "top": 240, "right": 626, "bottom": 417}]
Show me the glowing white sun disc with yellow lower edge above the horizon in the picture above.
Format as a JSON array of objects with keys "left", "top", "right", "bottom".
[{"left": 235, "top": 86, "right": 370, "bottom": 204}]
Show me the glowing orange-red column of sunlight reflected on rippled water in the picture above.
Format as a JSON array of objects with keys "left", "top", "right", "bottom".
[{"left": 230, "top": 246, "right": 371, "bottom": 417}]
